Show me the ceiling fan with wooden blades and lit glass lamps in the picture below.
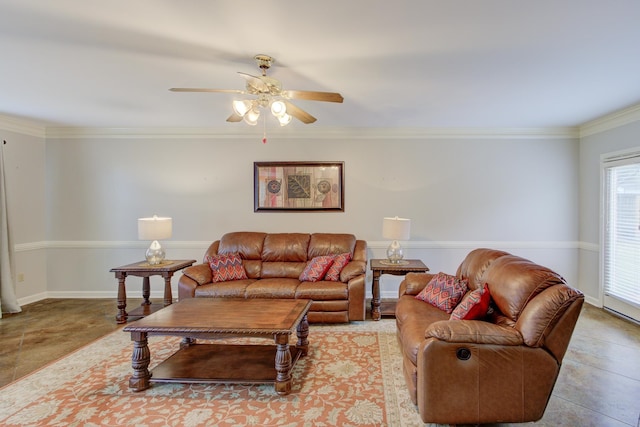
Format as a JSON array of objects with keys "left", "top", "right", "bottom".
[{"left": 169, "top": 54, "right": 344, "bottom": 126}]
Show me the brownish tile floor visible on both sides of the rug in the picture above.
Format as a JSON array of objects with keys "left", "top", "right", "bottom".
[{"left": 0, "top": 299, "right": 640, "bottom": 427}]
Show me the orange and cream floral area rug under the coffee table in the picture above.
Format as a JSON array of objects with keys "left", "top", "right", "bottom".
[{"left": 0, "top": 320, "right": 436, "bottom": 426}]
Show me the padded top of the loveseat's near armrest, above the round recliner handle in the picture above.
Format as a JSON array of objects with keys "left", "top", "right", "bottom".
[{"left": 424, "top": 320, "right": 524, "bottom": 346}]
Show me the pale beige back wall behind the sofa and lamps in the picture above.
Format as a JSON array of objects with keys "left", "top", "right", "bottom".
[{"left": 40, "top": 132, "right": 578, "bottom": 297}]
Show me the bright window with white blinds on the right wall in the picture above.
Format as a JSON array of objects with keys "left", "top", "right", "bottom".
[{"left": 603, "top": 153, "right": 640, "bottom": 307}]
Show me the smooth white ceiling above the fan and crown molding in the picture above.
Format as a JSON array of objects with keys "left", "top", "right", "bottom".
[{"left": 0, "top": 0, "right": 640, "bottom": 128}]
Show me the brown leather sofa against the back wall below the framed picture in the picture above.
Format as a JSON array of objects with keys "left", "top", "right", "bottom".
[{"left": 178, "top": 232, "right": 367, "bottom": 323}]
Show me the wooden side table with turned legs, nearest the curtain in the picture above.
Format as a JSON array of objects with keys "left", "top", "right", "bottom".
[{"left": 109, "top": 259, "right": 196, "bottom": 323}]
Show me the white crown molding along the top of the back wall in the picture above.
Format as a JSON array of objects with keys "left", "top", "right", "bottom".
[{"left": 46, "top": 126, "right": 579, "bottom": 141}]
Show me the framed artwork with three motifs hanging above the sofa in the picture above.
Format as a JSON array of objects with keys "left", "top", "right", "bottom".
[{"left": 253, "top": 161, "right": 344, "bottom": 212}]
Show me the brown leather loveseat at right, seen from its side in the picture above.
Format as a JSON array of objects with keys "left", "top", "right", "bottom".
[{"left": 396, "top": 249, "right": 584, "bottom": 424}]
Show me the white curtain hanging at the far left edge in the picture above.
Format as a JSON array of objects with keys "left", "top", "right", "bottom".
[{"left": 0, "top": 141, "right": 22, "bottom": 317}]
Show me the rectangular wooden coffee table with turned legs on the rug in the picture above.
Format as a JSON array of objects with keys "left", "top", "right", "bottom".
[{"left": 123, "top": 298, "right": 311, "bottom": 395}]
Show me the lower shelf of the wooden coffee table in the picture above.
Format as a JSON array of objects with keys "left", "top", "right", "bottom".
[{"left": 149, "top": 344, "right": 303, "bottom": 384}]
